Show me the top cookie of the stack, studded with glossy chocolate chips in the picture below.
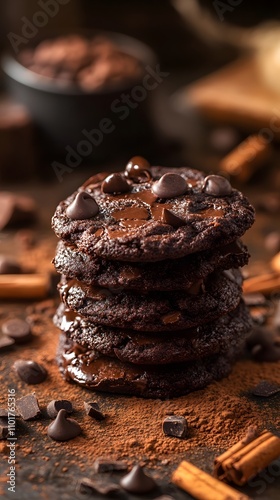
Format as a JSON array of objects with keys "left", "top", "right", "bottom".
[{"left": 52, "top": 157, "right": 254, "bottom": 262}]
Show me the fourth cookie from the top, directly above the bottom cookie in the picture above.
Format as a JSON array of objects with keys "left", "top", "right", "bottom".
[{"left": 54, "top": 302, "right": 251, "bottom": 365}]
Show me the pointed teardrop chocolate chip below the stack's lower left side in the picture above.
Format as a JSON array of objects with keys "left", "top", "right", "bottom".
[{"left": 48, "top": 410, "right": 82, "bottom": 441}]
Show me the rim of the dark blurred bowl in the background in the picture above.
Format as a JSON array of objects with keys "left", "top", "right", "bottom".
[{"left": 1, "top": 29, "right": 158, "bottom": 96}]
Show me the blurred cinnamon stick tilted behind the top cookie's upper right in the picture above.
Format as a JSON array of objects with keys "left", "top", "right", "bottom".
[{"left": 220, "top": 135, "right": 272, "bottom": 182}]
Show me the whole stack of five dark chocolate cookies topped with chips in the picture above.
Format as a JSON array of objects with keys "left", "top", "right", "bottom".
[{"left": 53, "top": 157, "right": 254, "bottom": 398}]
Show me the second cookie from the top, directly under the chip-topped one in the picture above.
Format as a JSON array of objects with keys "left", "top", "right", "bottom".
[{"left": 54, "top": 241, "right": 249, "bottom": 292}]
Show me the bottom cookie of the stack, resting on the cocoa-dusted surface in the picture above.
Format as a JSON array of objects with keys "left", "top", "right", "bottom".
[{"left": 58, "top": 334, "right": 240, "bottom": 399}]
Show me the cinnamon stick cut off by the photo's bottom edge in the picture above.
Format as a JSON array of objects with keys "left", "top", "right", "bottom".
[{"left": 172, "top": 461, "right": 249, "bottom": 500}]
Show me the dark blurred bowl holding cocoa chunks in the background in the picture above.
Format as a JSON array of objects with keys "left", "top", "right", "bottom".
[{"left": 2, "top": 31, "right": 156, "bottom": 168}]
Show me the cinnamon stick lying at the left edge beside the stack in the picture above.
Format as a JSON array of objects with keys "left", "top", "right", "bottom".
[{"left": 0, "top": 274, "right": 50, "bottom": 300}]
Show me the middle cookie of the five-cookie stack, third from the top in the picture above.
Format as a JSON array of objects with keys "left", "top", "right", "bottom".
[{"left": 59, "top": 270, "right": 242, "bottom": 332}]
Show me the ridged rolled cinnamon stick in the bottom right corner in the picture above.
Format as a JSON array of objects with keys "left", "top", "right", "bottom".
[{"left": 214, "top": 430, "right": 280, "bottom": 486}]
